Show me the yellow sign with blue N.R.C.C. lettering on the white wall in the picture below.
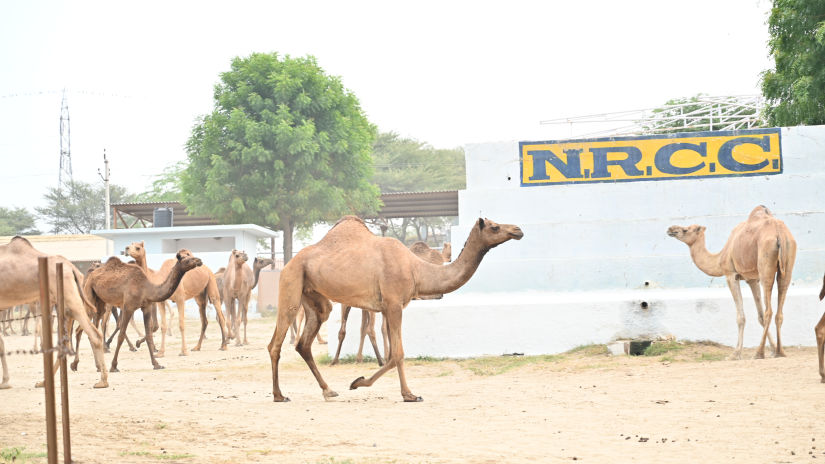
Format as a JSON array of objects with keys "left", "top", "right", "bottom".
[{"left": 519, "top": 128, "right": 782, "bottom": 187}]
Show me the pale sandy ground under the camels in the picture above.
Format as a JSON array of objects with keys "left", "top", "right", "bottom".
[{"left": 0, "top": 319, "right": 825, "bottom": 464}]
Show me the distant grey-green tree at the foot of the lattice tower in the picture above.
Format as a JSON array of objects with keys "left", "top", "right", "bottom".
[{"left": 35, "top": 181, "right": 134, "bottom": 234}]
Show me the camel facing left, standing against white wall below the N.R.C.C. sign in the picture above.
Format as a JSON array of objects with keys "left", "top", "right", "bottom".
[{"left": 667, "top": 205, "right": 796, "bottom": 359}]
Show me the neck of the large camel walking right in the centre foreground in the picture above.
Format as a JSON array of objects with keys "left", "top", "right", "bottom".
[{"left": 415, "top": 227, "right": 490, "bottom": 295}]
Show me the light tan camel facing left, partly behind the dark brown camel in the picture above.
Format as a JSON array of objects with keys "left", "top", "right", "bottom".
[{"left": 126, "top": 242, "right": 229, "bottom": 356}]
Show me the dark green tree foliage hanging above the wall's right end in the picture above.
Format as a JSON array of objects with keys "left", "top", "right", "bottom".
[{"left": 762, "top": 0, "right": 825, "bottom": 126}]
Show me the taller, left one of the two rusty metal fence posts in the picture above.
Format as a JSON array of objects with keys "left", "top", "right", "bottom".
[{"left": 37, "top": 256, "right": 57, "bottom": 464}]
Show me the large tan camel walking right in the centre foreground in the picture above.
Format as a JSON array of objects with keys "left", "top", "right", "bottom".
[{"left": 269, "top": 216, "right": 524, "bottom": 401}]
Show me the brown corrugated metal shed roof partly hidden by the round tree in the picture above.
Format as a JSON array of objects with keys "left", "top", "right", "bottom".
[{"left": 112, "top": 190, "right": 458, "bottom": 229}]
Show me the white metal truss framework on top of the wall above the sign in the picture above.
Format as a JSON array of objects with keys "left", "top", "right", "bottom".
[{"left": 539, "top": 95, "right": 764, "bottom": 138}]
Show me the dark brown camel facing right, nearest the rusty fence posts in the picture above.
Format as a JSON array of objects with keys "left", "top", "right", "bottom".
[{"left": 85, "top": 255, "right": 202, "bottom": 372}]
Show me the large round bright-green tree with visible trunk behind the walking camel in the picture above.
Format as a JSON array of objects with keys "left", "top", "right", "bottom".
[{"left": 181, "top": 53, "right": 379, "bottom": 260}]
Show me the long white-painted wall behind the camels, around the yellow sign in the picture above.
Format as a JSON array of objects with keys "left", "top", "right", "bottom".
[{"left": 330, "top": 126, "right": 825, "bottom": 356}]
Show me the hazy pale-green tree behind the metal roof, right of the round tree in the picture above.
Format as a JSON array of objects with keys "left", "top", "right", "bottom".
[{"left": 372, "top": 132, "right": 466, "bottom": 243}]
